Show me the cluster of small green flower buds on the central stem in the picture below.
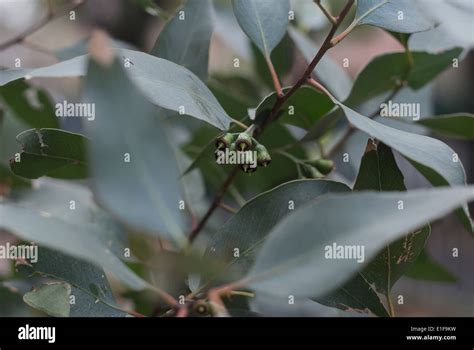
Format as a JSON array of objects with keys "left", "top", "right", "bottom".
[{"left": 215, "top": 132, "right": 272, "bottom": 173}]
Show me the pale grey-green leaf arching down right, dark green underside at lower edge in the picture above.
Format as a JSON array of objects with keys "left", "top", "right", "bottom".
[{"left": 334, "top": 100, "right": 472, "bottom": 232}]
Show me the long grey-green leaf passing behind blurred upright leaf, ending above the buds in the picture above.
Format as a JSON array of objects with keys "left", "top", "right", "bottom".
[{"left": 0, "top": 49, "right": 231, "bottom": 130}]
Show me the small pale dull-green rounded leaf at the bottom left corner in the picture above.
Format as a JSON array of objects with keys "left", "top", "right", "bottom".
[{"left": 23, "top": 283, "right": 71, "bottom": 317}]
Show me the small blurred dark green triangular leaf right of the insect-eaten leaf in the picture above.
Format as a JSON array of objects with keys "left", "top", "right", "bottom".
[{"left": 405, "top": 250, "right": 457, "bottom": 282}]
